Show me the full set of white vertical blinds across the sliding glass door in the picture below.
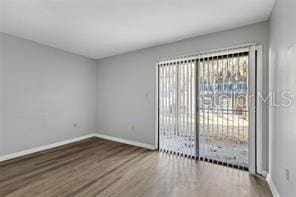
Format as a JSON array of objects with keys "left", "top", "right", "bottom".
[{"left": 158, "top": 43, "right": 254, "bottom": 169}]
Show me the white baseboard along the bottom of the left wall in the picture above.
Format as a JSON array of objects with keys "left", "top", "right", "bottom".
[{"left": 0, "top": 133, "right": 96, "bottom": 162}]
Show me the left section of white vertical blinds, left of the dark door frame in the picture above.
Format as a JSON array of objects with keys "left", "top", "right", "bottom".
[{"left": 159, "top": 60, "right": 196, "bottom": 156}]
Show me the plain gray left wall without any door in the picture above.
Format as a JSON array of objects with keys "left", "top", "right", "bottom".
[{"left": 0, "top": 33, "right": 96, "bottom": 155}]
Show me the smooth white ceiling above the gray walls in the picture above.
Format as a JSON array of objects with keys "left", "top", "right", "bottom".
[{"left": 0, "top": 0, "right": 275, "bottom": 59}]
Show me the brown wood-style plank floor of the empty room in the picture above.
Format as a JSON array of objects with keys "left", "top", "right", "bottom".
[{"left": 0, "top": 138, "right": 272, "bottom": 197}]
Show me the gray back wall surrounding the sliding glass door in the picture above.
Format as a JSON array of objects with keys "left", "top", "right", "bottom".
[{"left": 96, "top": 22, "right": 269, "bottom": 170}]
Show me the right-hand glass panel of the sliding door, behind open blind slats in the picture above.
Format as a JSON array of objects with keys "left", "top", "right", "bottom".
[{"left": 198, "top": 52, "right": 249, "bottom": 169}]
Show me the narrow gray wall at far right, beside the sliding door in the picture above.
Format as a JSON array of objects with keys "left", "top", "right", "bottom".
[{"left": 270, "top": 0, "right": 296, "bottom": 197}]
